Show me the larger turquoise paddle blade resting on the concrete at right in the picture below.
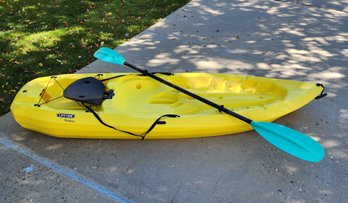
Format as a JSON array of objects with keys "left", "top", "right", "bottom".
[{"left": 251, "top": 121, "right": 325, "bottom": 162}]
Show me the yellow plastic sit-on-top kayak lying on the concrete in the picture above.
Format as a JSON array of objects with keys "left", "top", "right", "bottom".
[{"left": 11, "top": 73, "right": 323, "bottom": 139}]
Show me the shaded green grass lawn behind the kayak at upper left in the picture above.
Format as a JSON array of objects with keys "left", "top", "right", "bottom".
[{"left": 0, "top": 0, "right": 188, "bottom": 115}]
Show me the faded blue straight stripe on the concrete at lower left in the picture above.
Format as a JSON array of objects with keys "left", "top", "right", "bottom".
[{"left": 0, "top": 138, "right": 132, "bottom": 203}]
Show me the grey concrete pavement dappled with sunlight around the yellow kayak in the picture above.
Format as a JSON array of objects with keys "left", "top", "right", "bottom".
[{"left": 0, "top": 0, "right": 348, "bottom": 202}]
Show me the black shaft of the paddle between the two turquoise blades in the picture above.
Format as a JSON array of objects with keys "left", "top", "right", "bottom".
[{"left": 124, "top": 62, "right": 252, "bottom": 124}]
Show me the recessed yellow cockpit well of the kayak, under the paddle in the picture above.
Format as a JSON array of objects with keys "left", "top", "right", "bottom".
[{"left": 113, "top": 73, "right": 287, "bottom": 115}]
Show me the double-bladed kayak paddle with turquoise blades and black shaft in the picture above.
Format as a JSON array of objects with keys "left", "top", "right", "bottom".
[{"left": 94, "top": 47, "right": 325, "bottom": 162}]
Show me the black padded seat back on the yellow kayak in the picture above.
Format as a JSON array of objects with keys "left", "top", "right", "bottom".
[{"left": 63, "top": 77, "right": 109, "bottom": 105}]
